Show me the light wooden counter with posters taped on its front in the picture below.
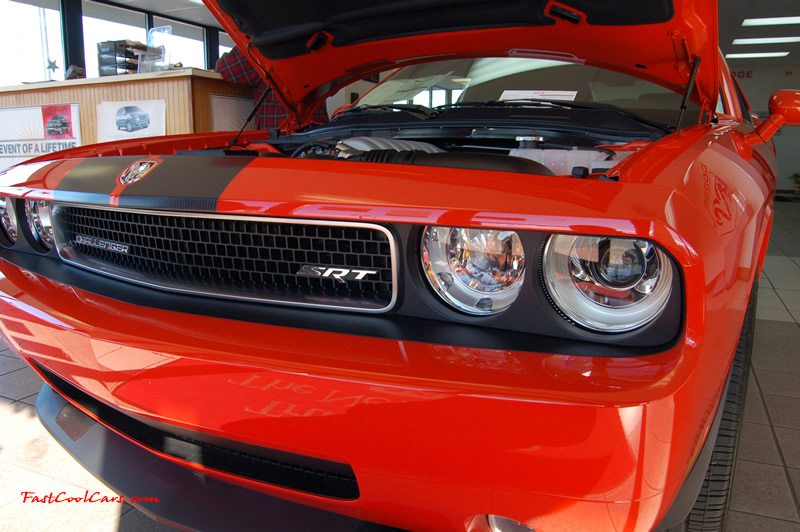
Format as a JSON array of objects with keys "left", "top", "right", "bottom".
[{"left": 0, "top": 68, "right": 253, "bottom": 144}]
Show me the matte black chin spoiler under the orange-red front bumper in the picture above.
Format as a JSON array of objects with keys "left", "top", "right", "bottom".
[{"left": 36, "top": 384, "right": 392, "bottom": 532}]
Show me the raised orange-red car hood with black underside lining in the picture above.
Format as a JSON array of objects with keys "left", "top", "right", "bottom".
[{"left": 204, "top": 0, "right": 720, "bottom": 130}]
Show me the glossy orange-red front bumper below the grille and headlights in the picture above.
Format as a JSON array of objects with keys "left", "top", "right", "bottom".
[{"left": 0, "top": 263, "right": 719, "bottom": 532}]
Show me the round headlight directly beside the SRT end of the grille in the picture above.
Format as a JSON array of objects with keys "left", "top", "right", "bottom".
[{"left": 422, "top": 226, "right": 525, "bottom": 316}]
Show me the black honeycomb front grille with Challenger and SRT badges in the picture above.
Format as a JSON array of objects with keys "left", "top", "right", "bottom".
[{"left": 54, "top": 206, "right": 395, "bottom": 311}]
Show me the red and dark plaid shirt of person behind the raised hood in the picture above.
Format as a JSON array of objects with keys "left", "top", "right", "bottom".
[{"left": 216, "top": 46, "right": 328, "bottom": 129}]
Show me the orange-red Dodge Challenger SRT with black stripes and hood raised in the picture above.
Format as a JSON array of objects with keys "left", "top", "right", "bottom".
[{"left": 0, "top": 0, "right": 800, "bottom": 532}]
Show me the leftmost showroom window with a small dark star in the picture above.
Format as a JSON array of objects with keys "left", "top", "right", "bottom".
[{"left": 0, "top": 0, "right": 64, "bottom": 86}]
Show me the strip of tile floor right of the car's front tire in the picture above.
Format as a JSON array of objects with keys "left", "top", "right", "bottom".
[{"left": 727, "top": 197, "right": 800, "bottom": 532}]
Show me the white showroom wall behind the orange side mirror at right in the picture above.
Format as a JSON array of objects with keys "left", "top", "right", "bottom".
[{"left": 730, "top": 64, "right": 800, "bottom": 190}]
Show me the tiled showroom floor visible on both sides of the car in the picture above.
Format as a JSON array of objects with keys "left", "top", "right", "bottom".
[{"left": 0, "top": 202, "right": 800, "bottom": 532}]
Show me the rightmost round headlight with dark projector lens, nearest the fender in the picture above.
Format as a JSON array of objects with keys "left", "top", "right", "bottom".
[{"left": 542, "top": 235, "right": 673, "bottom": 332}]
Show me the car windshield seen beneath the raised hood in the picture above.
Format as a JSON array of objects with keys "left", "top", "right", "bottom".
[{"left": 357, "top": 57, "right": 700, "bottom": 125}]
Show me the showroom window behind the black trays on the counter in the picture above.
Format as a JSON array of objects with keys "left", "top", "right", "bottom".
[{"left": 83, "top": 0, "right": 147, "bottom": 78}]
